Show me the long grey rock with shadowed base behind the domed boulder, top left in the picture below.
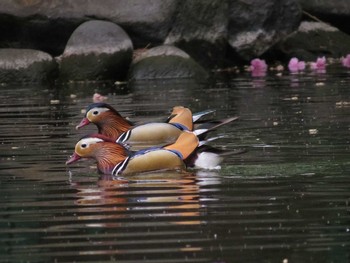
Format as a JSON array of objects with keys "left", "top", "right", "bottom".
[{"left": 0, "top": 0, "right": 178, "bottom": 56}]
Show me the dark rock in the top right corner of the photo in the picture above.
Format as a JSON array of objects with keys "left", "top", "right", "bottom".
[{"left": 299, "top": 0, "right": 350, "bottom": 34}]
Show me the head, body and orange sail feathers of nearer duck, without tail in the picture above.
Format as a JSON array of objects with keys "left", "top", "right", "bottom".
[{"left": 66, "top": 131, "right": 199, "bottom": 176}]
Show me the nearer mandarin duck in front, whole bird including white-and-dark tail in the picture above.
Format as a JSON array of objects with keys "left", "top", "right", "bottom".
[{"left": 66, "top": 117, "right": 241, "bottom": 176}]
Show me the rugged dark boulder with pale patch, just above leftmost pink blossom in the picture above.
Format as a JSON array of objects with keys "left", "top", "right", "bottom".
[{"left": 228, "top": 0, "right": 301, "bottom": 60}]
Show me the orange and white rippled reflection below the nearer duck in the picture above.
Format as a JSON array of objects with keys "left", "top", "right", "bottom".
[{"left": 76, "top": 171, "right": 205, "bottom": 227}]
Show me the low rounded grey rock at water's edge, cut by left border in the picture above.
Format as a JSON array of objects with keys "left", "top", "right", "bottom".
[{"left": 0, "top": 48, "right": 57, "bottom": 83}]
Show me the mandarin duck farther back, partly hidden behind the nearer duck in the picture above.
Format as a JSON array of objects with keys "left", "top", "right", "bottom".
[{"left": 76, "top": 103, "right": 213, "bottom": 145}]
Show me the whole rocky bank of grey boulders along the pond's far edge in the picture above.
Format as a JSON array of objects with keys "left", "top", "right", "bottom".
[{"left": 0, "top": 0, "right": 350, "bottom": 82}]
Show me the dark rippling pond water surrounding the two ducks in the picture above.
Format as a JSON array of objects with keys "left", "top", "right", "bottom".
[{"left": 0, "top": 68, "right": 350, "bottom": 263}]
